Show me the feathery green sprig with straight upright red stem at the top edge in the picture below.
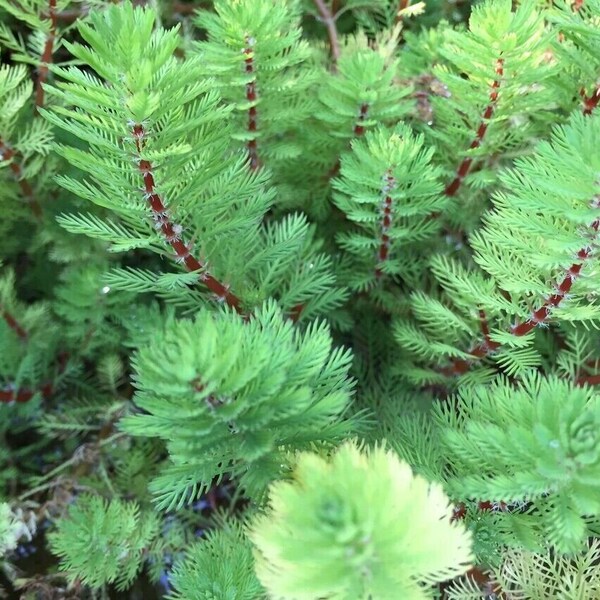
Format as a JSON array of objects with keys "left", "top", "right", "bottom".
[{"left": 195, "top": 0, "right": 316, "bottom": 167}]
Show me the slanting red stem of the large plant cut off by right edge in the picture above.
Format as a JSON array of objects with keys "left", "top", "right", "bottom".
[{"left": 450, "top": 197, "right": 600, "bottom": 375}]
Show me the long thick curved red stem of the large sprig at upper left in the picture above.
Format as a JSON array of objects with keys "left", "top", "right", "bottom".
[{"left": 132, "top": 123, "right": 243, "bottom": 314}]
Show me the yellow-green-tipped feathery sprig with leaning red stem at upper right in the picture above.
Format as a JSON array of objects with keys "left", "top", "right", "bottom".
[{"left": 425, "top": 0, "right": 556, "bottom": 231}]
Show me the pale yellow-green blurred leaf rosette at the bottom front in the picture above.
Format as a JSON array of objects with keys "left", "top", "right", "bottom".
[{"left": 250, "top": 443, "right": 471, "bottom": 600}]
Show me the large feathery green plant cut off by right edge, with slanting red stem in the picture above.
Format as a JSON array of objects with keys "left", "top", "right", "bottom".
[{"left": 395, "top": 114, "right": 600, "bottom": 381}]
